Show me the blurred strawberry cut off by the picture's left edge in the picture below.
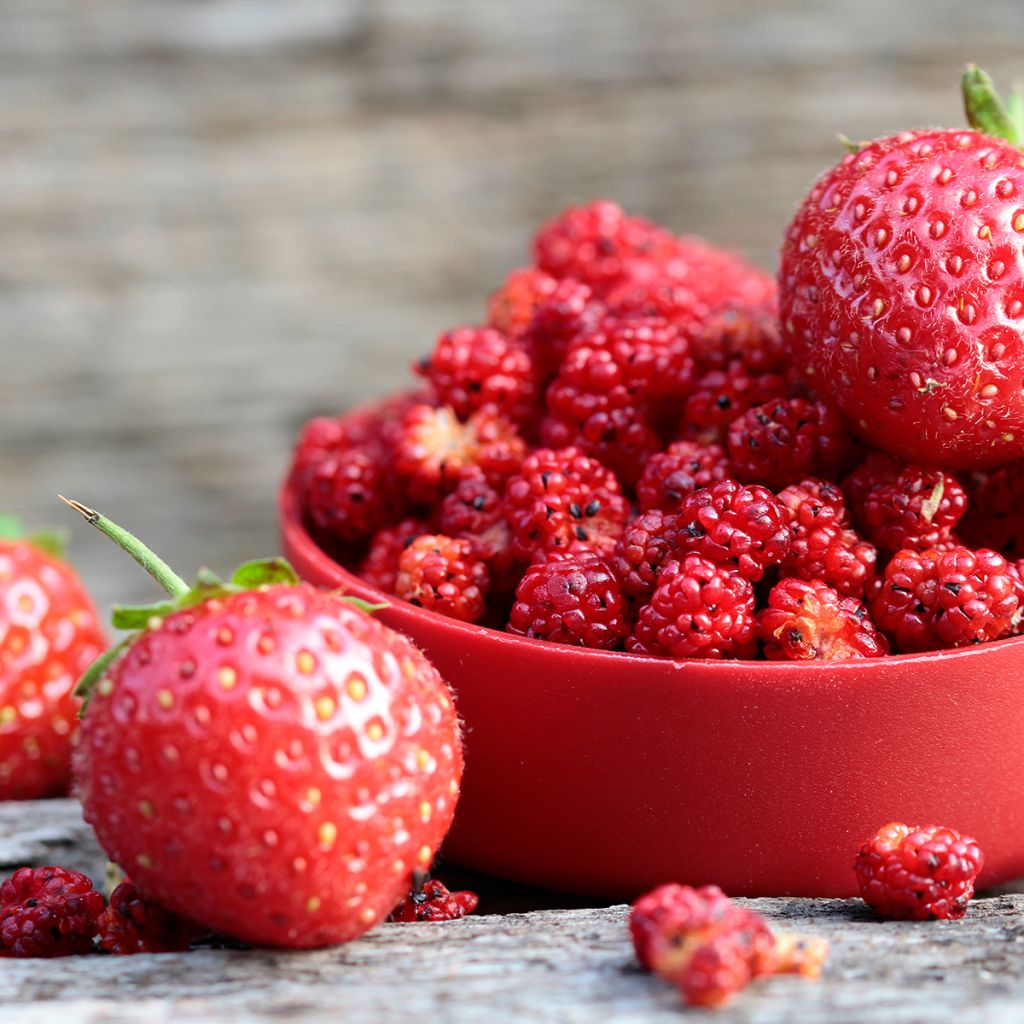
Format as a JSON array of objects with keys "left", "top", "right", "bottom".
[{"left": 0, "top": 516, "right": 105, "bottom": 800}]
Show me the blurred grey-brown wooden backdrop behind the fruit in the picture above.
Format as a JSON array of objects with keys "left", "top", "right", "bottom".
[{"left": 0, "top": 0, "right": 1024, "bottom": 604}]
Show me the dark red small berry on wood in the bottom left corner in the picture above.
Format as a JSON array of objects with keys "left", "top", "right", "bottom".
[{"left": 0, "top": 867, "right": 103, "bottom": 956}]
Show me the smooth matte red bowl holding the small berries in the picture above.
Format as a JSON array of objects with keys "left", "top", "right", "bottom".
[{"left": 280, "top": 485, "right": 1024, "bottom": 899}]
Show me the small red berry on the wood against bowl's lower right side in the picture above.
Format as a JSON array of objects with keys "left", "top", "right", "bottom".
[{"left": 853, "top": 821, "right": 984, "bottom": 921}]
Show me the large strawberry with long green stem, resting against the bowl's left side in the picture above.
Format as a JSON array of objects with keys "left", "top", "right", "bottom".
[{"left": 61, "top": 503, "right": 462, "bottom": 947}]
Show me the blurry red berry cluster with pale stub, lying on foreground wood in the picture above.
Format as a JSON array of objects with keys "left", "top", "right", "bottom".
[{"left": 630, "top": 883, "right": 828, "bottom": 1007}]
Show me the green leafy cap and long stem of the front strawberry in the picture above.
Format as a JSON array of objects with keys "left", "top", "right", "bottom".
[{"left": 60, "top": 495, "right": 387, "bottom": 718}]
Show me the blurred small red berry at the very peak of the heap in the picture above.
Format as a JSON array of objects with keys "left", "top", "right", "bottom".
[{"left": 534, "top": 200, "right": 672, "bottom": 295}]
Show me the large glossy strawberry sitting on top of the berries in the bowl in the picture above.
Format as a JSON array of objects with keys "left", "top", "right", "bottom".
[{"left": 779, "top": 68, "right": 1024, "bottom": 469}]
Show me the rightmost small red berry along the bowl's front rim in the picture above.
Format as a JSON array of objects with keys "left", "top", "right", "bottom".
[{"left": 871, "top": 546, "right": 1018, "bottom": 651}]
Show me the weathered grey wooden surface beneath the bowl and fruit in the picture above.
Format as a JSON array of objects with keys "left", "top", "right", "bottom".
[{"left": 0, "top": 801, "right": 1024, "bottom": 1024}]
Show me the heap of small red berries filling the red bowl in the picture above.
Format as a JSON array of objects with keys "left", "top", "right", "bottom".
[{"left": 292, "top": 201, "right": 1024, "bottom": 659}]
